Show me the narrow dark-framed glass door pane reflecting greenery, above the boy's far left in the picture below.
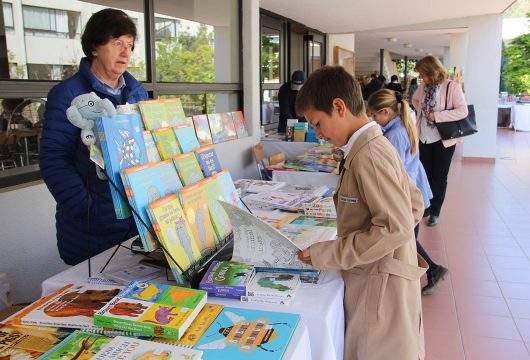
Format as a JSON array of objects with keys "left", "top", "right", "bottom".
[{"left": 261, "top": 26, "right": 280, "bottom": 84}]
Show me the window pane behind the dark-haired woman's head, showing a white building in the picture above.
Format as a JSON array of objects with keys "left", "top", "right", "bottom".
[{"left": 0, "top": 0, "right": 146, "bottom": 81}]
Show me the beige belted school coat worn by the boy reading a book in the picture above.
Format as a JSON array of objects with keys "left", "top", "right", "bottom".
[{"left": 310, "top": 126, "right": 427, "bottom": 360}]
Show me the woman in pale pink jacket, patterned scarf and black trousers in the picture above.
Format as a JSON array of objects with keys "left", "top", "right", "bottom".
[{"left": 412, "top": 56, "right": 467, "bottom": 226}]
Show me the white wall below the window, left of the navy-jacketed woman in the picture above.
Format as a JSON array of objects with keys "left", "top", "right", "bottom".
[{"left": 0, "top": 183, "right": 68, "bottom": 304}]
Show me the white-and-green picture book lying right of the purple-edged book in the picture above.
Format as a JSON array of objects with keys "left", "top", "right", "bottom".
[{"left": 241, "top": 272, "right": 300, "bottom": 305}]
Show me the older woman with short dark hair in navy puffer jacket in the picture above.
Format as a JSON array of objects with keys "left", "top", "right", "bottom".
[{"left": 40, "top": 9, "right": 148, "bottom": 265}]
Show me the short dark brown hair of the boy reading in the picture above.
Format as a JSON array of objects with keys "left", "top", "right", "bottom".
[{"left": 296, "top": 66, "right": 365, "bottom": 116}]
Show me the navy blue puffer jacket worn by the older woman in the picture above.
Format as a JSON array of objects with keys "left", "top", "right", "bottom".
[{"left": 40, "top": 58, "right": 148, "bottom": 265}]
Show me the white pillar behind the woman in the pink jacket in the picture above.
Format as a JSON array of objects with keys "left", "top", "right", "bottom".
[{"left": 462, "top": 15, "right": 502, "bottom": 158}]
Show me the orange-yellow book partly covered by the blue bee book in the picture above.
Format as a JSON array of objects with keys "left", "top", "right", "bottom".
[{"left": 151, "top": 303, "right": 224, "bottom": 347}]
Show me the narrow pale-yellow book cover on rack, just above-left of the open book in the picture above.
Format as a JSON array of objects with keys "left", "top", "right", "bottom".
[{"left": 202, "top": 177, "right": 232, "bottom": 244}]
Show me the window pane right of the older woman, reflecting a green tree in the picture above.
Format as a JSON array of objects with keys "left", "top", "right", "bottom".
[{"left": 154, "top": 0, "right": 236, "bottom": 83}]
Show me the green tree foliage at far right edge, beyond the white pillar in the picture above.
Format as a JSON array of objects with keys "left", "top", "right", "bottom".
[{"left": 502, "top": 34, "right": 530, "bottom": 94}]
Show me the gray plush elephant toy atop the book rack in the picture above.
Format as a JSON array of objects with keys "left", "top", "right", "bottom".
[{"left": 66, "top": 92, "right": 116, "bottom": 146}]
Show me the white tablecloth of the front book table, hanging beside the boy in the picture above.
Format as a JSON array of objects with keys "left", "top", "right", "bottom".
[{"left": 42, "top": 240, "right": 344, "bottom": 360}]
